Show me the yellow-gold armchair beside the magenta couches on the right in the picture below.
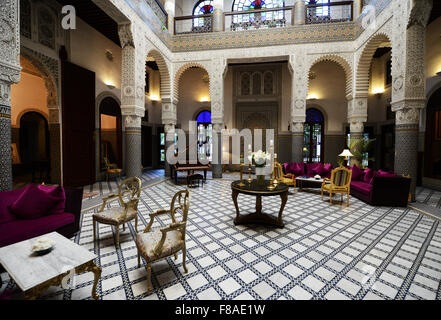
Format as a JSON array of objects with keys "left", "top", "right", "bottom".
[{"left": 322, "top": 167, "right": 352, "bottom": 207}]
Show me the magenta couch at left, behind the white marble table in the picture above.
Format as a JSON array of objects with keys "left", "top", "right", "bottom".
[{"left": 0, "top": 188, "right": 83, "bottom": 247}]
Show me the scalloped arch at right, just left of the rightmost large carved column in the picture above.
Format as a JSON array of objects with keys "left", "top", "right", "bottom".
[{"left": 355, "top": 33, "right": 393, "bottom": 94}]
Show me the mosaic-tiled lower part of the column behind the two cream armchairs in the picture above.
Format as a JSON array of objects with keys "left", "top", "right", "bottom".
[{"left": 124, "top": 127, "right": 142, "bottom": 177}]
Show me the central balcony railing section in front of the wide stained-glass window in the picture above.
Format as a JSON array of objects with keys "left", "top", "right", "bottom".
[{"left": 224, "top": 7, "right": 293, "bottom": 31}]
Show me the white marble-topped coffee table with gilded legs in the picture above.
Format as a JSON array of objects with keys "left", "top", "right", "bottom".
[{"left": 0, "top": 232, "right": 101, "bottom": 300}]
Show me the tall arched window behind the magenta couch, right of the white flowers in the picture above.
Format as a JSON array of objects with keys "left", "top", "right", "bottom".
[{"left": 303, "top": 108, "right": 325, "bottom": 163}]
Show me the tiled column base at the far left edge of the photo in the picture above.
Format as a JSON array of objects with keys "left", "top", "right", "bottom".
[{"left": 0, "top": 109, "right": 12, "bottom": 191}]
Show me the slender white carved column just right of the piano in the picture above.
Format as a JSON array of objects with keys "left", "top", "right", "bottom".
[{"left": 210, "top": 58, "right": 227, "bottom": 178}]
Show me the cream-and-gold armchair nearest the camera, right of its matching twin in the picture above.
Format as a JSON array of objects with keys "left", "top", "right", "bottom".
[{"left": 136, "top": 190, "right": 190, "bottom": 292}]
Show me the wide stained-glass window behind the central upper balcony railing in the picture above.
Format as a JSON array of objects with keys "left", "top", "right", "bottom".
[{"left": 232, "top": 0, "right": 285, "bottom": 23}]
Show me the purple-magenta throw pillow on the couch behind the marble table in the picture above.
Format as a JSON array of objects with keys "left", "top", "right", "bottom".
[{"left": 9, "top": 184, "right": 58, "bottom": 219}]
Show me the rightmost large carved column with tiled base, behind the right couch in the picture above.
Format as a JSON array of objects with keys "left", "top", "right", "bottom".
[{"left": 392, "top": 0, "right": 433, "bottom": 201}]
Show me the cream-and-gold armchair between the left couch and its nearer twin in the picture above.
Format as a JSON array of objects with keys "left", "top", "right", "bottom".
[{"left": 92, "top": 177, "right": 141, "bottom": 246}]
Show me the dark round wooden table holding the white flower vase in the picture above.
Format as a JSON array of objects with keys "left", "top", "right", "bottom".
[{"left": 231, "top": 180, "right": 289, "bottom": 228}]
